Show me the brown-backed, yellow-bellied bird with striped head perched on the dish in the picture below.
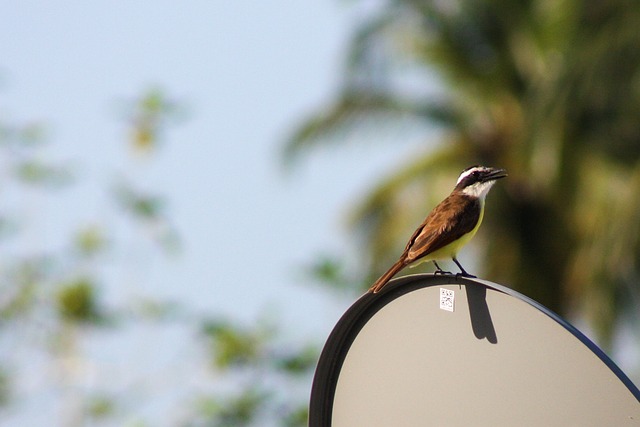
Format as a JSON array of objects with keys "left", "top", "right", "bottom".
[{"left": 368, "top": 165, "right": 507, "bottom": 293}]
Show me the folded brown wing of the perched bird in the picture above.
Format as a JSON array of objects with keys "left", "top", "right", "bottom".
[{"left": 405, "top": 193, "right": 481, "bottom": 263}]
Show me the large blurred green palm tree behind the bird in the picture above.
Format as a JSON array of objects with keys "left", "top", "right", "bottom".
[{"left": 286, "top": 0, "right": 640, "bottom": 345}]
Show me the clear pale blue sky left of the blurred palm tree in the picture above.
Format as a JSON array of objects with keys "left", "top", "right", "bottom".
[{"left": 0, "top": 0, "right": 430, "bottom": 426}]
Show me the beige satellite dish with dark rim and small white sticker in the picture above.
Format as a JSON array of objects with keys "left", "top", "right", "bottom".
[{"left": 309, "top": 274, "right": 640, "bottom": 427}]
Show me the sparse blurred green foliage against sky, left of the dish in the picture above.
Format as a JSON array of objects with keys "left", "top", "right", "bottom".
[{"left": 0, "top": 88, "right": 318, "bottom": 427}]
